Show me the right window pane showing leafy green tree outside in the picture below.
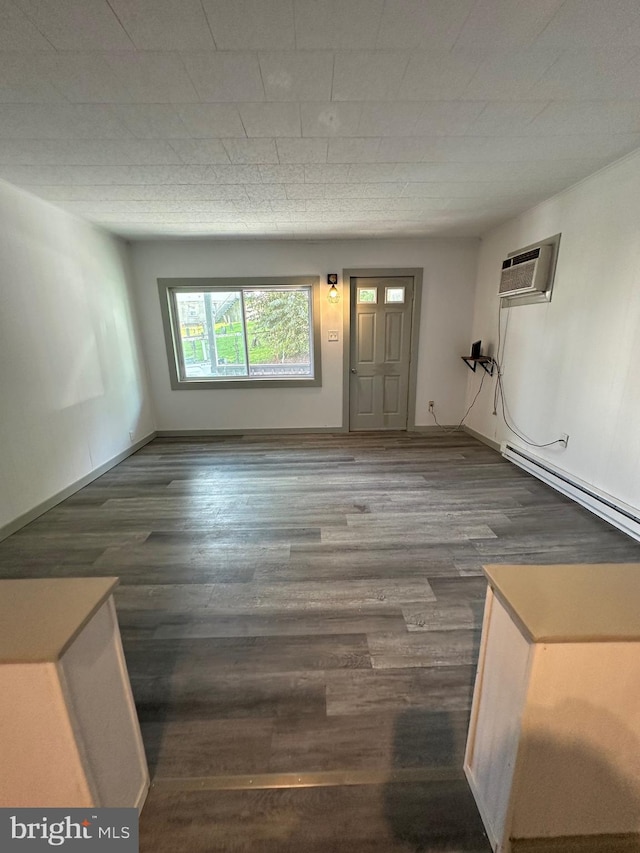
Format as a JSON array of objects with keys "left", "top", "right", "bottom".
[{"left": 244, "top": 288, "right": 313, "bottom": 378}]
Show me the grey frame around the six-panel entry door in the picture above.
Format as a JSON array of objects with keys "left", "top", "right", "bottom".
[{"left": 342, "top": 267, "right": 424, "bottom": 432}]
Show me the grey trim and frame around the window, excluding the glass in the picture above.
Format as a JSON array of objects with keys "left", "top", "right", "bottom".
[{"left": 158, "top": 276, "right": 322, "bottom": 391}]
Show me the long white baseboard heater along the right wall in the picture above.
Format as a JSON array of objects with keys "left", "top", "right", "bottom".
[{"left": 500, "top": 441, "right": 640, "bottom": 542}]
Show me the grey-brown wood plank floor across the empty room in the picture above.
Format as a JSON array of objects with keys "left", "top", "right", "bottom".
[{"left": 0, "top": 433, "right": 640, "bottom": 853}]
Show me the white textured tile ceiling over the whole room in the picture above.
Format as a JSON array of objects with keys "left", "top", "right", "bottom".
[{"left": 0, "top": 0, "right": 640, "bottom": 238}]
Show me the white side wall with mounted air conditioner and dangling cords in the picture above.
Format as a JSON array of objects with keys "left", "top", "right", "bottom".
[{"left": 468, "top": 146, "right": 640, "bottom": 509}]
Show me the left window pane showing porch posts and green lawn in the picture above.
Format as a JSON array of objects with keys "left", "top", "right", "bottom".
[{"left": 176, "top": 290, "right": 247, "bottom": 379}]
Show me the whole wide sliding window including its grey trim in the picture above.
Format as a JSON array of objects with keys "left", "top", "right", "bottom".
[{"left": 158, "top": 276, "right": 321, "bottom": 389}]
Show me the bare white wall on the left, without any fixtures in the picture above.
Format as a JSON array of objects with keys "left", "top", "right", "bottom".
[{"left": 0, "top": 182, "right": 154, "bottom": 528}]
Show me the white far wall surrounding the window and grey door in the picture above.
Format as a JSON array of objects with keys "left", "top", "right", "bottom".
[{"left": 133, "top": 239, "right": 478, "bottom": 430}]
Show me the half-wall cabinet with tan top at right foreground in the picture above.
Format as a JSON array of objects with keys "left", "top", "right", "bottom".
[{"left": 465, "top": 564, "right": 640, "bottom": 853}]
